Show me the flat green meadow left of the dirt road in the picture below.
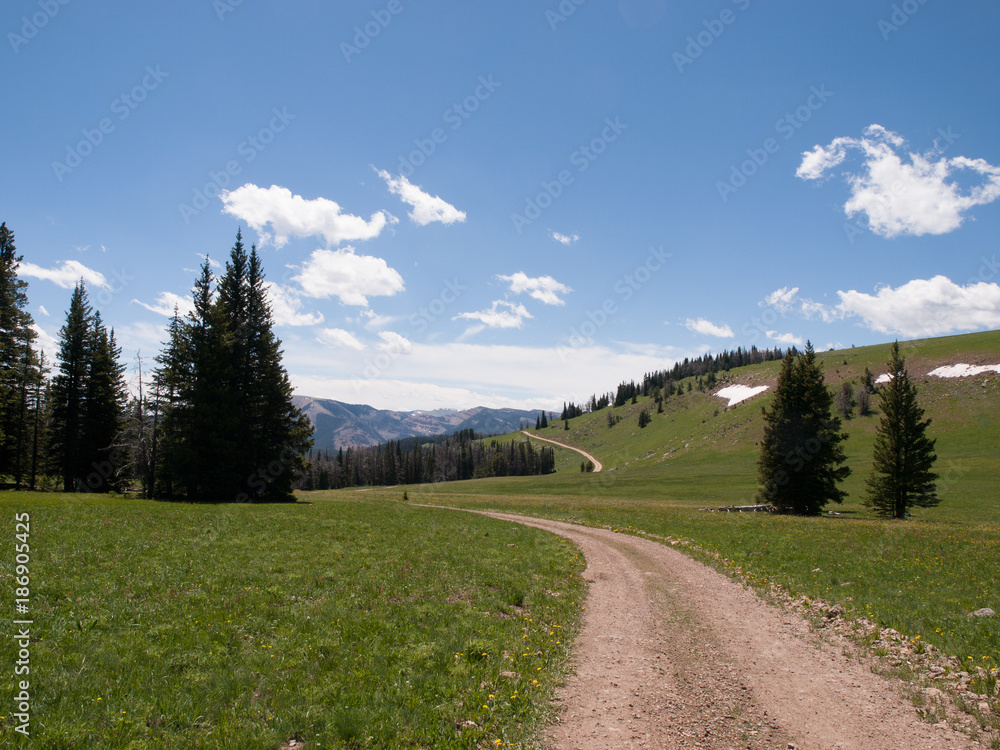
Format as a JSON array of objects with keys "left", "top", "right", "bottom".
[{"left": 0, "top": 493, "right": 584, "bottom": 748}]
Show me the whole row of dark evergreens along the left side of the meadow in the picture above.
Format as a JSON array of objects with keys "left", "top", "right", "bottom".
[{"left": 0, "top": 224, "right": 312, "bottom": 502}]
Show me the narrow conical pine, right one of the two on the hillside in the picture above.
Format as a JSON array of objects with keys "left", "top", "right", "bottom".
[{"left": 865, "top": 341, "right": 941, "bottom": 519}]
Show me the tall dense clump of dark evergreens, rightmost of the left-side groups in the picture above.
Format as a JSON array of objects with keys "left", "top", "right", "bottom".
[{"left": 153, "top": 233, "right": 312, "bottom": 502}]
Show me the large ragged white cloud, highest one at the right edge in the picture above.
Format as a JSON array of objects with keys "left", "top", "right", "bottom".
[{"left": 795, "top": 125, "right": 1000, "bottom": 237}]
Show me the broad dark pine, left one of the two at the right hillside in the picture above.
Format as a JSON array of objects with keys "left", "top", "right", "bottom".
[{"left": 758, "top": 344, "right": 850, "bottom": 515}]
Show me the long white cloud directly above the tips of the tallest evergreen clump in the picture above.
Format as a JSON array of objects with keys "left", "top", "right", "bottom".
[{"left": 219, "top": 183, "right": 395, "bottom": 248}]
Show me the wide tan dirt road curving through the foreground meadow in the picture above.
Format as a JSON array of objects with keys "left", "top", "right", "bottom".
[{"left": 489, "top": 513, "right": 985, "bottom": 750}]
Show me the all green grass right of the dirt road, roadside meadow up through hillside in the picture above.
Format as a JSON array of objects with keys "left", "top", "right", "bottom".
[{"left": 338, "top": 331, "right": 1000, "bottom": 692}]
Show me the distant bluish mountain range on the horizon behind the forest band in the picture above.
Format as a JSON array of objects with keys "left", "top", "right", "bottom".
[{"left": 292, "top": 396, "right": 540, "bottom": 451}]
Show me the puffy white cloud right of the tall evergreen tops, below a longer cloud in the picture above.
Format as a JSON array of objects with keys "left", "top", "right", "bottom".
[{"left": 293, "top": 246, "right": 405, "bottom": 307}]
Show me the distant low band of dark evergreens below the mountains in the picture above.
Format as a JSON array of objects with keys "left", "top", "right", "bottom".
[{"left": 297, "top": 430, "right": 555, "bottom": 490}]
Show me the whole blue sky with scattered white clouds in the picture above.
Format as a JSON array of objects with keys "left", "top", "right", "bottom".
[{"left": 0, "top": 0, "right": 1000, "bottom": 410}]
